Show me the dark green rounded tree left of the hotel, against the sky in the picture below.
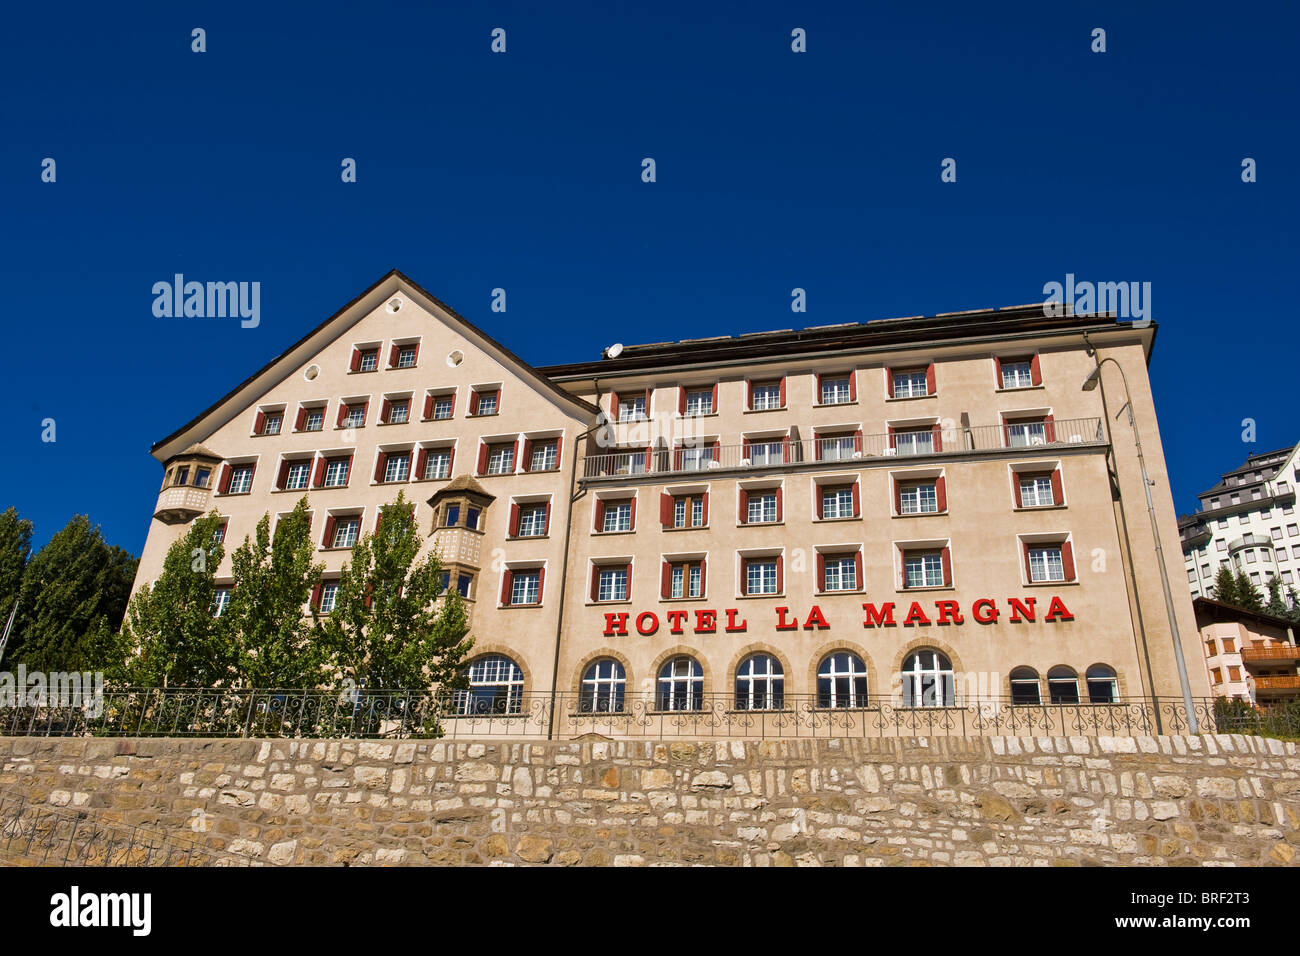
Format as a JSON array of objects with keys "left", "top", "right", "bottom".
[{"left": 5, "top": 515, "right": 138, "bottom": 671}]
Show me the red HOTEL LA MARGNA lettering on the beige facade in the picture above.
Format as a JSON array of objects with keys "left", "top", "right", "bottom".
[{"left": 605, "top": 594, "right": 1074, "bottom": 637}]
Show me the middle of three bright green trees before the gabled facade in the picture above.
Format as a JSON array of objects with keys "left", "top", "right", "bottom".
[{"left": 221, "top": 497, "right": 326, "bottom": 688}]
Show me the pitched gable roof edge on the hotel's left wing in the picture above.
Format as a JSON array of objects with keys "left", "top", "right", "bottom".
[{"left": 150, "top": 269, "right": 599, "bottom": 460}]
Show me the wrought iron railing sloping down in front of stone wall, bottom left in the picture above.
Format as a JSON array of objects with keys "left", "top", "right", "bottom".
[{"left": 0, "top": 791, "right": 256, "bottom": 866}]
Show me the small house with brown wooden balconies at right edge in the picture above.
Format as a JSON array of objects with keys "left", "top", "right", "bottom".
[{"left": 1192, "top": 597, "right": 1300, "bottom": 706}]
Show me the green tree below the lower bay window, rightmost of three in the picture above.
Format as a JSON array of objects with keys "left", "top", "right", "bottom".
[{"left": 312, "top": 494, "right": 473, "bottom": 689}]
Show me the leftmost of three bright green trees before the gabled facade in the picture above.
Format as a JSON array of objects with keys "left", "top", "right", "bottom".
[{"left": 121, "top": 511, "right": 235, "bottom": 687}]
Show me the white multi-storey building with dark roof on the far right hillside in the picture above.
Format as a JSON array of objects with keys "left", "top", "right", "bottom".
[{"left": 1178, "top": 445, "right": 1300, "bottom": 598}]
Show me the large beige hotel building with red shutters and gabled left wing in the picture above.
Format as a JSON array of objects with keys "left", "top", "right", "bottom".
[{"left": 137, "top": 265, "right": 1209, "bottom": 732}]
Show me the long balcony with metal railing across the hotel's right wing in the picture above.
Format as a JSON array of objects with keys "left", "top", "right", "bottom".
[{"left": 582, "top": 418, "right": 1106, "bottom": 480}]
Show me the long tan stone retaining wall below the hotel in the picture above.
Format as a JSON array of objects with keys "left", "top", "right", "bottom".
[{"left": 0, "top": 735, "right": 1300, "bottom": 866}]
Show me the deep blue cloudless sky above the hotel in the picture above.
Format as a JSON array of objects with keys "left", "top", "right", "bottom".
[{"left": 0, "top": 0, "right": 1300, "bottom": 554}]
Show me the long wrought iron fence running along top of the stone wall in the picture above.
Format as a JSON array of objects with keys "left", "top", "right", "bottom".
[{"left": 0, "top": 685, "right": 1279, "bottom": 739}]
